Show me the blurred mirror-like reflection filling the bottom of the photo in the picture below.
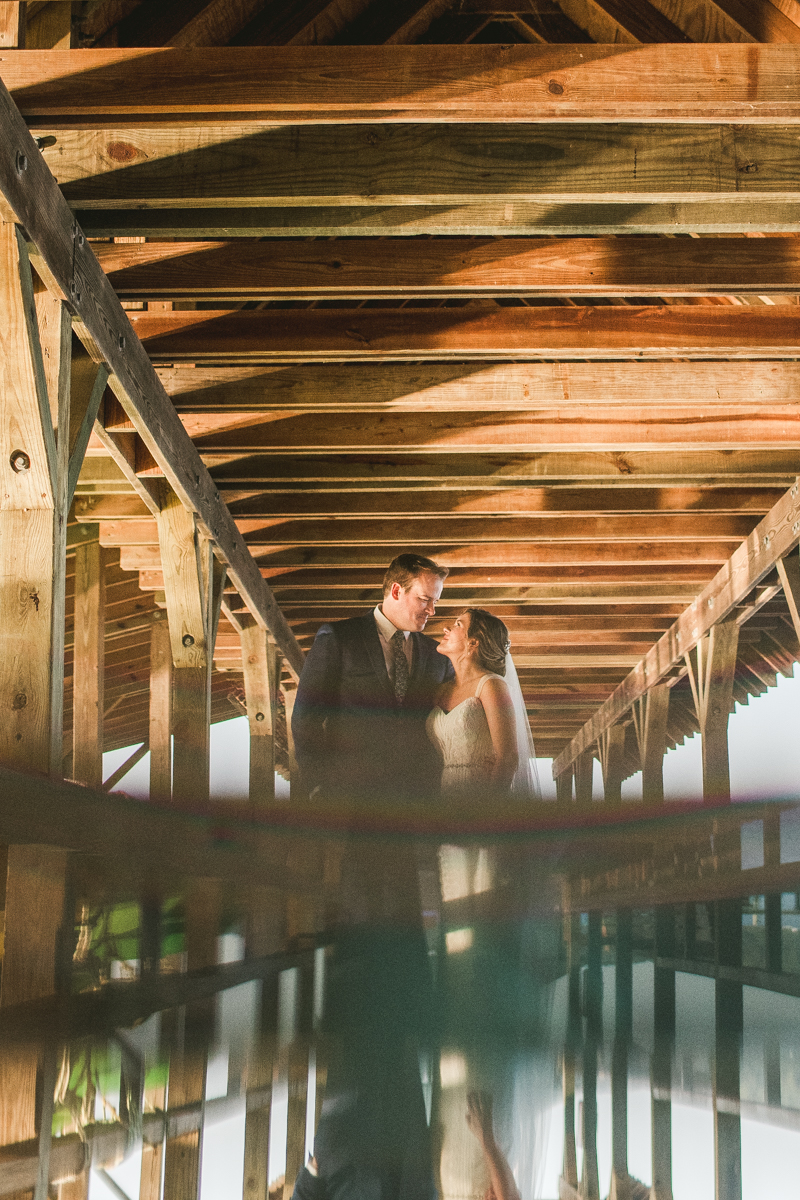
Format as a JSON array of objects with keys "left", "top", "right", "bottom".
[{"left": 0, "top": 805, "right": 800, "bottom": 1200}]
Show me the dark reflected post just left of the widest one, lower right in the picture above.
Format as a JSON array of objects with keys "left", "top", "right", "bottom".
[{"left": 650, "top": 907, "right": 675, "bottom": 1200}]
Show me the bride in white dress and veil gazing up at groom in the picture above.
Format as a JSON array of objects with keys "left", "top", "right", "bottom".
[{"left": 426, "top": 608, "right": 541, "bottom": 799}]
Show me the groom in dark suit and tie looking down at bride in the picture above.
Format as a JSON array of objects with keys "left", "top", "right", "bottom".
[{"left": 291, "top": 553, "right": 452, "bottom": 802}]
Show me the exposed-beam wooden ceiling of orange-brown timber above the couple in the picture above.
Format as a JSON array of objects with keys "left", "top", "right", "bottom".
[{"left": 0, "top": 0, "right": 800, "bottom": 770}]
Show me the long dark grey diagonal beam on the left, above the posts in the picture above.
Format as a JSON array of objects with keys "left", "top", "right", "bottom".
[{"left": 0, "top": 72, "right": 302, "bottom": 672}]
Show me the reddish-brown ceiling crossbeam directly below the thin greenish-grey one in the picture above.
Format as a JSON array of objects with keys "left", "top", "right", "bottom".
[{"left": 94, "top": 234, "right": 800, "bottom": 300}]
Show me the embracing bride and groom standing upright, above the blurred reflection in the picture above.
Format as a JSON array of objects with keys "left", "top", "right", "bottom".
[{"left": 291, "top": 553, "right": 537, "bottom": 802}]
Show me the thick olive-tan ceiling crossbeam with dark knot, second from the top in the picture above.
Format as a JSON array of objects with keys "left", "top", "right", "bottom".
[{"left": 38, "top": 122, "right": 800, "bottom": 210}]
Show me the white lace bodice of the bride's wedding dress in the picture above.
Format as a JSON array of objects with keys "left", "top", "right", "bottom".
[{"left": 426, "top": 674, "right": 494, "bottom": 796}]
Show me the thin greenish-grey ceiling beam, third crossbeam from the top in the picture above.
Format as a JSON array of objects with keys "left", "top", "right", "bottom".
[{"left": 76, "top": 196, "right": 800, "bottom": 239}]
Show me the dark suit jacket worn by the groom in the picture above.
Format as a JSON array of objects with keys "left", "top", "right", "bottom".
[{"left": 291, "top": 612, "right": 452, "bottom": 800}]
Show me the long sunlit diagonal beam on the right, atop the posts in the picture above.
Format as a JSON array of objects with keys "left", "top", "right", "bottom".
[{"left": 553, "top": 481, "right": 800, "bottom": 774}]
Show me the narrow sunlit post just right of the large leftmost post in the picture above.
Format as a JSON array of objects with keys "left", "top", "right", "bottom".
[{"left": 72, "top": 541, "right": 106, "bottom": 787}]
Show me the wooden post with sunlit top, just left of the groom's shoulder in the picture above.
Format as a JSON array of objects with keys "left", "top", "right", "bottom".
[{"left": 240, "top": 623, "right": 279, "bottom": 805}]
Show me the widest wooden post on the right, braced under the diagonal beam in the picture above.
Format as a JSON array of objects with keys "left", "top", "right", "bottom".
[{"left": 685, "top": 620, "right": 739, "bottom": 803}]
